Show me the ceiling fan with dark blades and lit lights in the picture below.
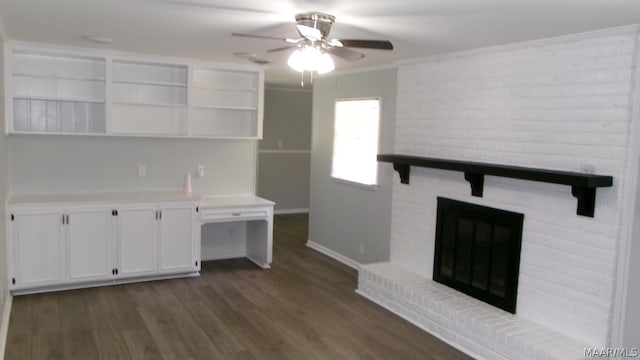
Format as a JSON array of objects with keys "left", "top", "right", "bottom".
[{"left": 232, "top": 12, "right": 393, "bottom": 73}]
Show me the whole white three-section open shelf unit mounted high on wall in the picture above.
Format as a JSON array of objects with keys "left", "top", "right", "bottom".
[{"left": 5, "top": 41, "right": 264, "bottom": 139}]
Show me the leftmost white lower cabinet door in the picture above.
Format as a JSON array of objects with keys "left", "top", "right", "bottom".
[{"left": 12, "top": 210, "right": 65, "bottom": 288}]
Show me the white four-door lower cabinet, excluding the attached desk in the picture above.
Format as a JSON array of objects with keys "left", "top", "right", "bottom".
[{"left": 9, "top": 198, "right": 200, "bottom": 291}]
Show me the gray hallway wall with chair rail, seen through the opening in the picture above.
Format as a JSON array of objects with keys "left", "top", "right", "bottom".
[{"left": 257, "top": 87, "right": 312, "bottom": 213}]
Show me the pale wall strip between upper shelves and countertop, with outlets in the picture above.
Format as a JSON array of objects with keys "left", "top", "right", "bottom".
[{"left": 9, "top": 135, "right": 256, "bottom": 195}]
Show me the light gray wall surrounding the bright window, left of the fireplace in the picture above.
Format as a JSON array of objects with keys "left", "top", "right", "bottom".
[{"left": 309, "top": 69, "right": 396, "bottom": 263}]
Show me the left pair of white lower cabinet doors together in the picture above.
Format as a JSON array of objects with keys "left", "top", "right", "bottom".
[{"left": 11, "top": 207, "right": 115, "bottom": 288}]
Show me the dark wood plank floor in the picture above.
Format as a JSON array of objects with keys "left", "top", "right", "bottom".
[{"left": 5, "top": 215, "right": 467, "bottom": 360}]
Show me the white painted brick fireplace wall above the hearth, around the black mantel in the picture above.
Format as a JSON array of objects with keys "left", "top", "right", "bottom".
[{"left": 391, "top": 28, "right": 638, "bottom": 347}]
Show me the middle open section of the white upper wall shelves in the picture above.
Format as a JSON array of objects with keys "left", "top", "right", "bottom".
[{"left": 111, "top": 60, "right": 188, "bottom": 135}]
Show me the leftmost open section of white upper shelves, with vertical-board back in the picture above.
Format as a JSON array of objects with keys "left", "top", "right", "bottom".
[{"left": 8, "top": 51, "right": 106, "bottom": 134}]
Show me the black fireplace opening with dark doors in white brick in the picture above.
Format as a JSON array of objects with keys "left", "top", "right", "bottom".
[{"left": 433, "top": 197, "right": 524, "bottom": 314}]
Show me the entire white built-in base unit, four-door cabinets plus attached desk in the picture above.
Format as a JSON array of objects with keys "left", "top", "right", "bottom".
[{"left": 7, "top": 192, "right": 274, "bottom": 294}]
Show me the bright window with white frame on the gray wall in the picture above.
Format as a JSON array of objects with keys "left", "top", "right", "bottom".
[{"left": 331, "top": 99, "right": 380, "bottom": 185}]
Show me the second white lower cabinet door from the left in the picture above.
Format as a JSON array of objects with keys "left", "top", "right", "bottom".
[{"left": 67, "top": 208, "right": 116, "bottom": 281}]
